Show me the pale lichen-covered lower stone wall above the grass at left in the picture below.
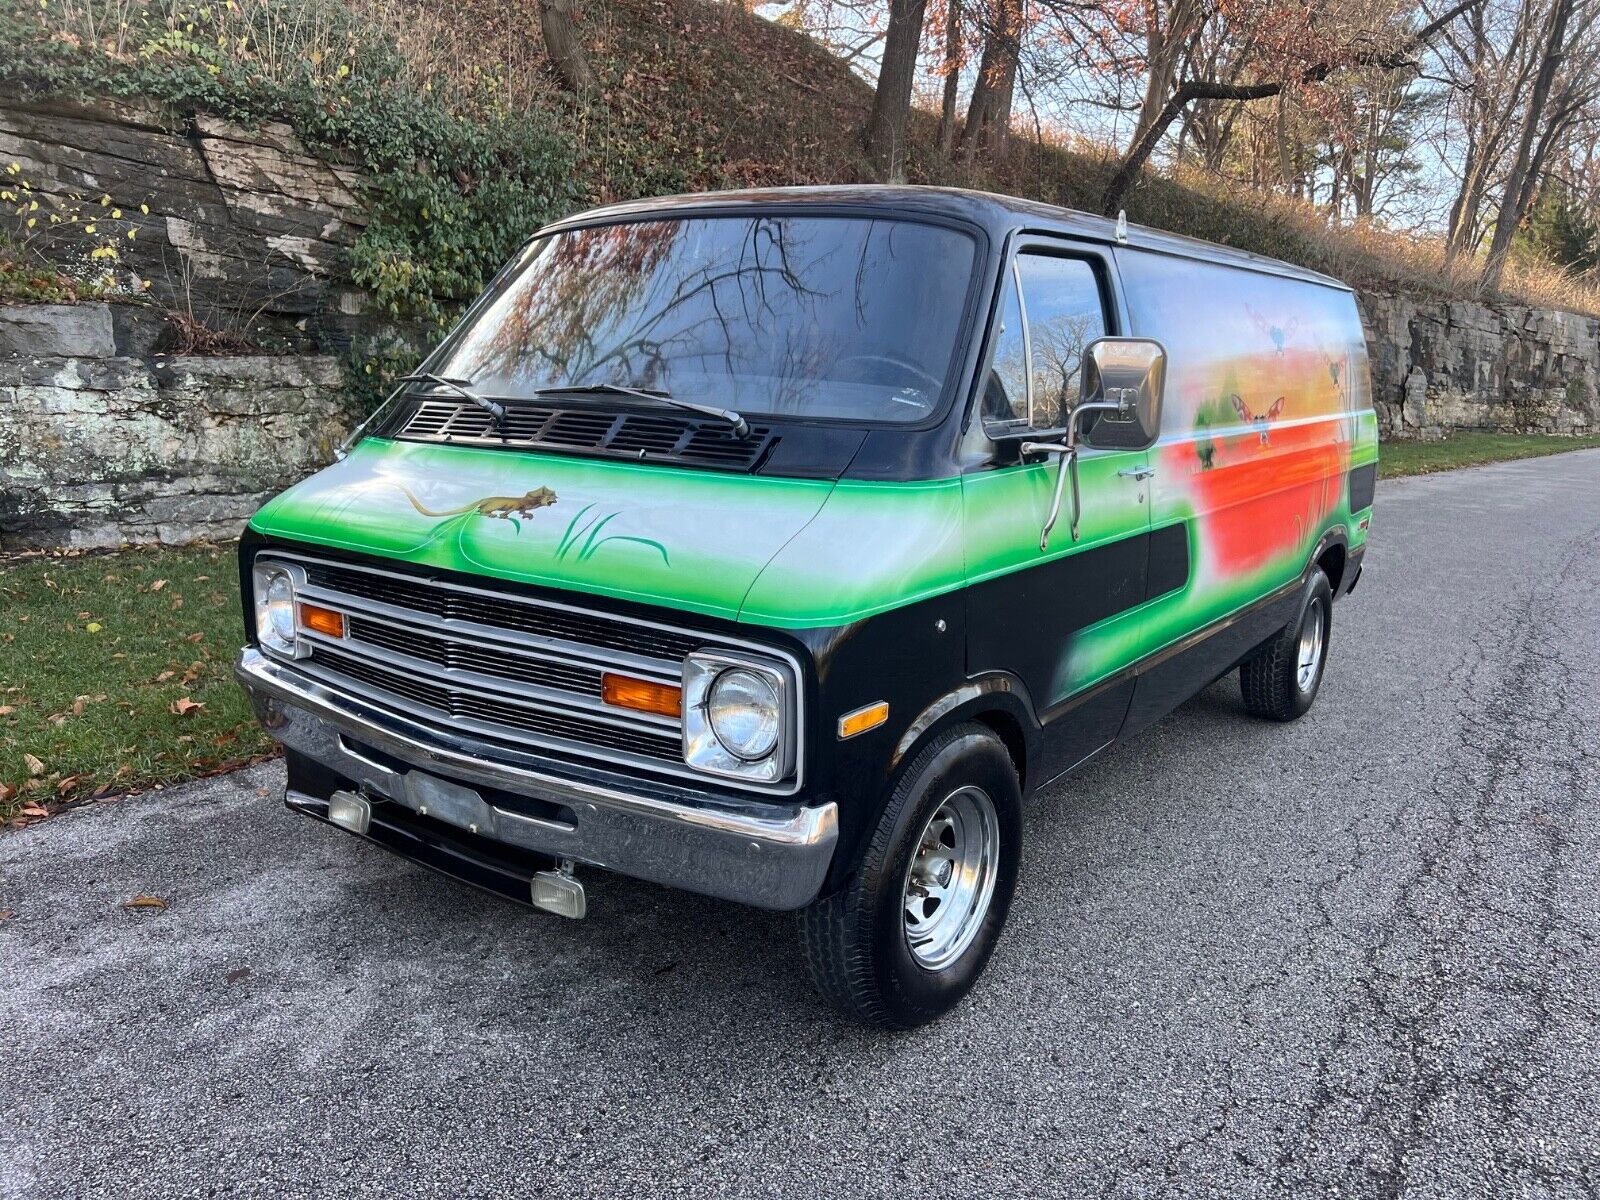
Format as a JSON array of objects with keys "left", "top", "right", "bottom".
[{"left": 0, "top": 304, "right": 357, "bottom": 549}]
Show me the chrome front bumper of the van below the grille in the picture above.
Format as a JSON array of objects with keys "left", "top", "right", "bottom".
[{"left": 234, "top": 650, "right": 838, "bottom": 909}]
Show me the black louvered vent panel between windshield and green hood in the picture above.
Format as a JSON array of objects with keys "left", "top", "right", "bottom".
[{"left": 390, "top": 400, "right": 778, "bottom": 472}]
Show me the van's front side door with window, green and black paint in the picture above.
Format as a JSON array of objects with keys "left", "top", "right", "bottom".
[{"left": 963, "top": 245, "right": 1150, "bottom": 778}]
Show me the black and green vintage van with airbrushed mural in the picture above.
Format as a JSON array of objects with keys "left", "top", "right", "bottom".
[{"left": 238, "top": 187, "right": 1378, "bottom": 1026}]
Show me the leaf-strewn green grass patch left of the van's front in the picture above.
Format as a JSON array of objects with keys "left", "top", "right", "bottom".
[{"left": 0, "top": 546, "right": 272, "bottom": 821}]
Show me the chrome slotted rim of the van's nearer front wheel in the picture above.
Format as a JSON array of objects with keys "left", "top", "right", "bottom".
[{"left": 901, "top": 787, "right": 1000, "bottom": 971}]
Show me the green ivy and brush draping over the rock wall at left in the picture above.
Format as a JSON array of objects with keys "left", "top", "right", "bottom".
[{"left": 0, "top": 0, "right": 586, "bottom": 334}]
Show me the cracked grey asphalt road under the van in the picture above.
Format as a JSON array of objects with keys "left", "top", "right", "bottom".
[{"left": 0, "top": 451, "right": 1600, "bottom": 1197}]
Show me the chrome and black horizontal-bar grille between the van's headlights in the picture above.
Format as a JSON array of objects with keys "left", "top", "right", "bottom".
[{"left": 264, "top": 552, "right": 717, "bottom": 774}]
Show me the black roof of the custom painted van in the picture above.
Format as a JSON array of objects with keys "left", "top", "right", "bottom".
[{"left": 550, "top": 184, "right": 1350, "bottom": 291}]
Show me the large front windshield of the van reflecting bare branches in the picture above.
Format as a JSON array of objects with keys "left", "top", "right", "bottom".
[{"left": 434, "top": 216, "right": 976, "bottom": 422}]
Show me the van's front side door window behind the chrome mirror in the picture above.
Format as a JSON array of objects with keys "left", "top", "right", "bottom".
[{"left": 982, "top": 254, "right": 1106, "bottom": 429}]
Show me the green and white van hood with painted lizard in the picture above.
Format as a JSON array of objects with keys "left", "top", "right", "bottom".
[{"left": 250, "top": 438, "right": 834, "bottom": 619}]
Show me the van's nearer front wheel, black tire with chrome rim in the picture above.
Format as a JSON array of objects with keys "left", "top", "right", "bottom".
[{"left": 802, "top": 725, "right": 1022, "bottom": 1029}]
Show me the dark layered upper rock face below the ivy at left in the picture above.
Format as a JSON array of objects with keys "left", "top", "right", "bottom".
[{"left": 0, "top": 98, "right": 366, "bottom": 350}]
